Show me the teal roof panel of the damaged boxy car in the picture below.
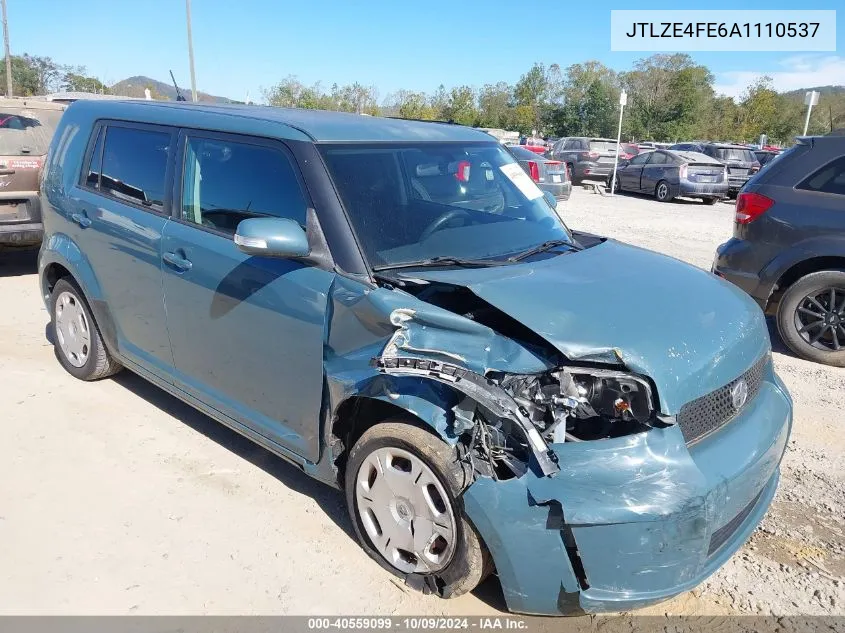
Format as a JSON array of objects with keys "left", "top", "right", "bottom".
[{"left": 66, "top": 100, "right": 495, "bottom": 143}]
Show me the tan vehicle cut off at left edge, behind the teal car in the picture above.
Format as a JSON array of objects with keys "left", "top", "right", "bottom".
[{"left": 0, "top": 98, "right": 65, "bottom": 249}]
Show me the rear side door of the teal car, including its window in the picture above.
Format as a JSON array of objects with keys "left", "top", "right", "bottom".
[{"left": 72, "top": 121, "right": 176, "bottom": 372}]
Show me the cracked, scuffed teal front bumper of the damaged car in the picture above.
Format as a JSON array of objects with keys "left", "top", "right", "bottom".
[{"left": 464, "top": 365, "right": 792, "bottom": 615}]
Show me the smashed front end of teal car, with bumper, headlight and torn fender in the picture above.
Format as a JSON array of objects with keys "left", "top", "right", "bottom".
[{"left": 362, "top": 298, "right": 791, "bottom": 614}]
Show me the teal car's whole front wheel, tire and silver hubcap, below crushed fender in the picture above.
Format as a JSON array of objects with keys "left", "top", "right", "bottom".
[{"left": 345, "top": 422, "right": 490, "bottom": 598}]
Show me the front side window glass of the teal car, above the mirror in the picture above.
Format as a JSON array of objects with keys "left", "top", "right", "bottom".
[{"left": 181, "top": 137, "right": 307, "bottom": 235}]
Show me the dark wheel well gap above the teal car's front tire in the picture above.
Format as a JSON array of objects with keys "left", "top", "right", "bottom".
[{"left": 330, "top": 396, "right": 440, "bottom": 487}]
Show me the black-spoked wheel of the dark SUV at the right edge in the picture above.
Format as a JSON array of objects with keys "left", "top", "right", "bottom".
[{"left": 777, "top": 270, "right": 845, "bottom": 367}]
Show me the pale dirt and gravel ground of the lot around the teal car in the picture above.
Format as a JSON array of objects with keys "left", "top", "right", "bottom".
[{"left": 0, "top": 189, "right": 845, "bottom": 615}]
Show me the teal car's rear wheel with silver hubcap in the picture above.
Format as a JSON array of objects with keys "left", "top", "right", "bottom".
[{"left": 50, "top": 278, "right": 121, "bottom": 380}]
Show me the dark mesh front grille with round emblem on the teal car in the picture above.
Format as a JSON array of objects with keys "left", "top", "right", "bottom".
[{"left": 677, "top": 354, "right": 770, "bottom": 444}]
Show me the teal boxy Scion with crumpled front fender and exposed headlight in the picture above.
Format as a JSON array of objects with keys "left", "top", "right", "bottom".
[{"left": 39, "top": 101, "right": 792, "bottom": 614}]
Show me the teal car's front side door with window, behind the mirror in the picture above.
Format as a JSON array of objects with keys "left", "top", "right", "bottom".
[{"left": 162, "top": 132, "right": 334, "bottom": 461}]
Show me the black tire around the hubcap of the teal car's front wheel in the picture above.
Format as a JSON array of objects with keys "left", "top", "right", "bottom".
[{"left": 345, "top": 421, "right": 492, "bottom": 598}]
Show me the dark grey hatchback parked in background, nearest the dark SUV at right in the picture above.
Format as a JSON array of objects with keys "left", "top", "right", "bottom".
[{"left": 608, "top": 149, "right": 728, "bottom": 204}]
